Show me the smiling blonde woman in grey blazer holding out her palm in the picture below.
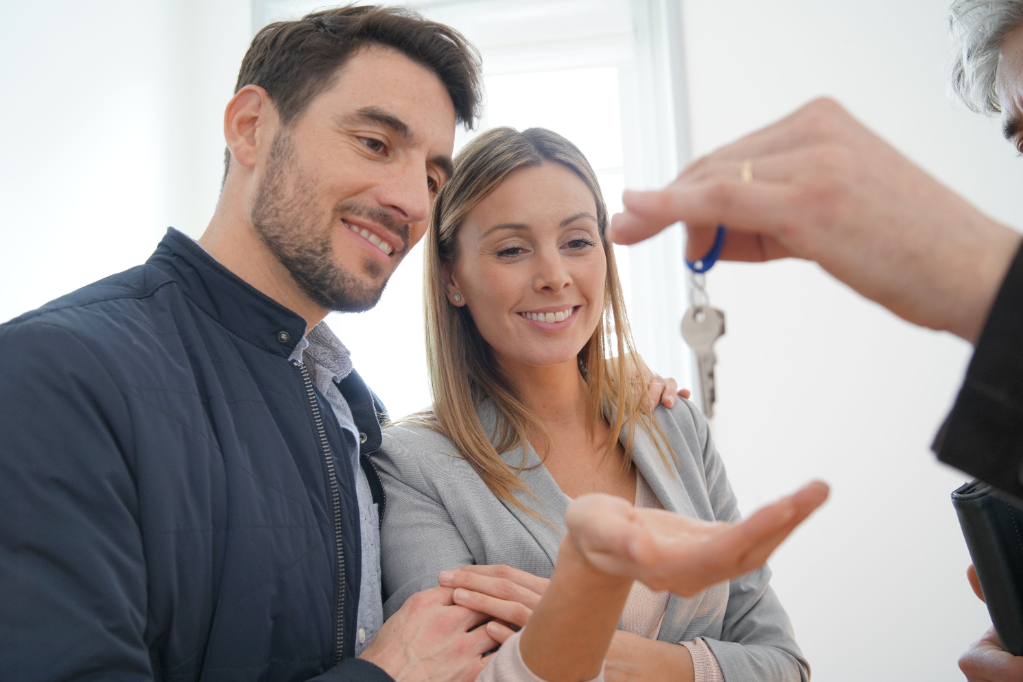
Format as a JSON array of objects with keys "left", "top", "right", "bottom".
[{"left": 379, "top": 128, "right": 827, "bottom": 681}]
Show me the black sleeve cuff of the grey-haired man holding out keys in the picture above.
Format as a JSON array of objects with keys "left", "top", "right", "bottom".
[{"left": 932, "top": 240, "right": 1023, "bottom": 500}]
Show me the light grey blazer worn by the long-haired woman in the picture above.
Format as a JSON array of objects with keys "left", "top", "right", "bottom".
[{"left": 374, "top": 400, "right": 809, "bottom": 682}]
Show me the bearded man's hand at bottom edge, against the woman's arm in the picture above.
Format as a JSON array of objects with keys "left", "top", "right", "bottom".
[{"left": 360, "top": 587, "right": 499, "bottom": 682}]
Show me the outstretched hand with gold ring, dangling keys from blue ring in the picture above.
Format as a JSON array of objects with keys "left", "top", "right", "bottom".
[{"left": 612, "top": 99, "right": 1020, "bottom": 343}]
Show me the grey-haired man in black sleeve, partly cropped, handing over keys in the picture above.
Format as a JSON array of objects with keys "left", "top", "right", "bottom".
[{"left": 613, "top": 0, "right": 1023, "bottom": 680}]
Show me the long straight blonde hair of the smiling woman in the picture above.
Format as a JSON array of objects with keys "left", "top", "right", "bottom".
[{"left": 410, "top": 128, "right": 665, "bottom": 509}]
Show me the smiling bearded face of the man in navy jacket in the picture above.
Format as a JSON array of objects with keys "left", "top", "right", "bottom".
[{"left": 252, "top": 46, "right": 455, "bottom": 312}]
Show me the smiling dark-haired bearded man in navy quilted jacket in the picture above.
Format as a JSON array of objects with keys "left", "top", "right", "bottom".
[{"left": 0, "top": 2, "right": 736, "bottom": 681}]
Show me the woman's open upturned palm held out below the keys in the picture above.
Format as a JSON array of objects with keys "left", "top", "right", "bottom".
[{"left": 565, "top": 482, "right": 829, "bottom": 596}]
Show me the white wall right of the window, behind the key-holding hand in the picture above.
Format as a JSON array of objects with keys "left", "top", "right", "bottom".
[{"left": 682, "top": 0, "right": 1023, "bottom": 682}]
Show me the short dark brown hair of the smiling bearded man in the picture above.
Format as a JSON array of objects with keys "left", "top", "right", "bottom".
[{"left": 224, "top": 5, "right": 482, "bottom": 180}]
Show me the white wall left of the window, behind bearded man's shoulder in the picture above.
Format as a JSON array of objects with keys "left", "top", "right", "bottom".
[{"left": 0, "top": 0, "right": 250, "bottom": 321}]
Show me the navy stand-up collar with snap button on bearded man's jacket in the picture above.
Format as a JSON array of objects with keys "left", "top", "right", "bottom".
[{"left": 146, "top": 227, "right": 306, "bottom": 359}]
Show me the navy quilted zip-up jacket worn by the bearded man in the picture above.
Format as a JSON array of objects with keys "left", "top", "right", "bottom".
[{"left": 0, "top": 229, "right": 390, "bottom": 681}]
